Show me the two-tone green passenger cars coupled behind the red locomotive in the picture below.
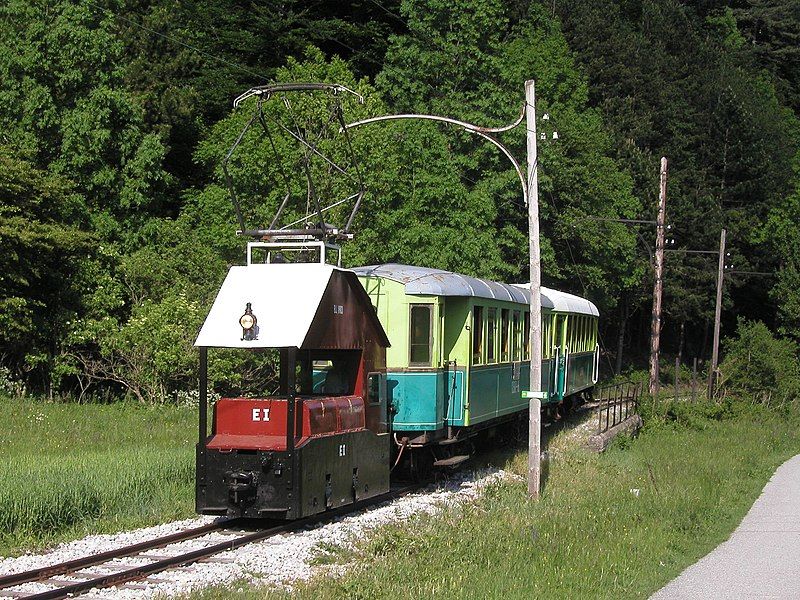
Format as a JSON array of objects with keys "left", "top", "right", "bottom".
[{"left": 353, "top": 264, "right": 598, "bottom": 442}]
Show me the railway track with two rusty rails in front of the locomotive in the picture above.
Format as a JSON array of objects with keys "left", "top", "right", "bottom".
[{"left": 0, "top": 483, "right": 426, "bottom": 600}]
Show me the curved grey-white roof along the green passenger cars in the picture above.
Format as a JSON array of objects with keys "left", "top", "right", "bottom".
[{"left": 351, "top": 263, "right": 600, "bottom": 317}]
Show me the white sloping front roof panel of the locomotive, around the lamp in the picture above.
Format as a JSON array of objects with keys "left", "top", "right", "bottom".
[{"left": 194, "top": 263, "right": 337, "bottom": 348}]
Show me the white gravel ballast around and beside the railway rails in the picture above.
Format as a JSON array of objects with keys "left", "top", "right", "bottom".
[{"left": 0, "top": 469, "right": 517, "bottom": 599}]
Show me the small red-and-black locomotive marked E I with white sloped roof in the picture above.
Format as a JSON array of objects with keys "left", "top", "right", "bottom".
[{"left": 195, "top": 241, "right": 390, "bottom": 519}]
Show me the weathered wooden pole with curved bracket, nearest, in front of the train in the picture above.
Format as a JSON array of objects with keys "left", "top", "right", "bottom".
[{"left": 525, "top": 80, "right": 542, "bottom": 499}]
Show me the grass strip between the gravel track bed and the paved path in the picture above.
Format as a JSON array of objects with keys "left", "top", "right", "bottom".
[{"left": 186, "top": 403, "right": 800, "bottom": 600}]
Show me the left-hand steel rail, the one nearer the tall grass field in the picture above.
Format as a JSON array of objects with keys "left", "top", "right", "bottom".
[{"left": 0, "top": 519, "right": 234, "bottom": 596}]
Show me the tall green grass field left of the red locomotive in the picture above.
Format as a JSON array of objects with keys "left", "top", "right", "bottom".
[{"left": 0, "top": 398, "right": 196, "bottom": 555}]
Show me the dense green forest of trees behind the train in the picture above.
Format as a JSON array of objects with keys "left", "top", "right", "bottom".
[{"left": 0, "top": 0, "right": 800, "bottom": 401}]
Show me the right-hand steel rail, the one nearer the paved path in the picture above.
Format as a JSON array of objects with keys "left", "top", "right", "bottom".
[{"left": 9, "top": 482, "right": 427, "bottom": 600}]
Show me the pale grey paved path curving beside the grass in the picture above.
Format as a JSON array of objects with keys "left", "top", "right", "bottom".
[{"left": 651, "top": 455, "right": 800, "bottom": 600}]
